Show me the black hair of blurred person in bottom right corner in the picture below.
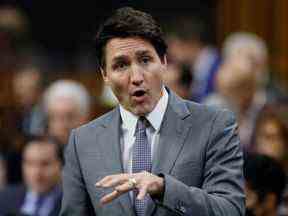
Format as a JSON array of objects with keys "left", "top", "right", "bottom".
[{"left": 244, "top": 153, "right": 286, "bottom": 204}]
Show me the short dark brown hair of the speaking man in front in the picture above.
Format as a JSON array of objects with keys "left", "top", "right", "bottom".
[{"left": 95, "top": 7, "right": 167, "bottom": 67}]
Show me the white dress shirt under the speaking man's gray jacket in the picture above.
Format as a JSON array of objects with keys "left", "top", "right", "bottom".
[{"left": 120, "top": 87, "right": 168, "bottom": 173}]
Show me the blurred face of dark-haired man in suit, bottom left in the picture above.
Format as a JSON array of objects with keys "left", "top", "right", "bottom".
[{"left": 22, "top": 142, "right": 61, "bottom": 194}]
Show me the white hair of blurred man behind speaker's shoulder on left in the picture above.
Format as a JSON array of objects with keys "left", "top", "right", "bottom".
[{"left": 43, "top": 80, "right": 90, "bottom": 115}]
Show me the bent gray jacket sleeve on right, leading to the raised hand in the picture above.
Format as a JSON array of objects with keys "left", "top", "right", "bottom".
[{"left": 158, "top": 111, "right": 245, "bottom": 216}]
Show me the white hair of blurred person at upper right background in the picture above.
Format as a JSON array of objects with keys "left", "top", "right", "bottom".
[{"left": 223, "top": 32, "right": 268, "bottom": 60}]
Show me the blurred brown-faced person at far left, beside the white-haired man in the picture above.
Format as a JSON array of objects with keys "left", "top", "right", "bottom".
[{"left": 13, "top": 66, "right": 45, "bottom": 137}]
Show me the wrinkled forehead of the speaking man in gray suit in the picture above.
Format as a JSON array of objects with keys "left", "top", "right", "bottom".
[{"left": 106, "top": 37, "right": 156, "bottom": 61}]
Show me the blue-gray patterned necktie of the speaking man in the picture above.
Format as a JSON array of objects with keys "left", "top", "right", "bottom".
[{"left": 132, "top": 117, "right": 152, "bottom": 216}]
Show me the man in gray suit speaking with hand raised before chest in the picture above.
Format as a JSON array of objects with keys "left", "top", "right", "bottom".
[{"left": 61, "top": 8, "right": 245, "bottom": 216}]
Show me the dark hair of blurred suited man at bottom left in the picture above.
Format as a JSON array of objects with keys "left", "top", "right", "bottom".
[{"left": 24, "top": 136, "right": 64, "bottom": 164}]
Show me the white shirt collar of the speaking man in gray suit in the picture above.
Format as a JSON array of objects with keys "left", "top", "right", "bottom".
[{"left": 120, "top": 86, "right": 168, "bottom": 131}]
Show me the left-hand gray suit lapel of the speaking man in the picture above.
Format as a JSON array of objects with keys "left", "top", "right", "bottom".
[{"left": 96, "top": 108, "right": 134, "bottom": 215}]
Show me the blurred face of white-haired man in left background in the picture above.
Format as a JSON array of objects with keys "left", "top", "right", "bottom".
[{"left": 48, "top": 98, "right": 88, "bottom": 144}]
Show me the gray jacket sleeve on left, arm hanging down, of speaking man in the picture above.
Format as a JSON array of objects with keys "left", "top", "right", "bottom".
[{"left": 60, "top": 130, "right": 95, "bottom": 216}]
